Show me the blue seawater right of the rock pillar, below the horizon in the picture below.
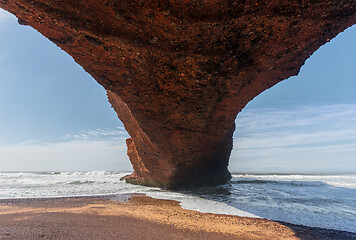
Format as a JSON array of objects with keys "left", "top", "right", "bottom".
[{"left": 230, "top": 174, "right": 356, "bottom": 232}]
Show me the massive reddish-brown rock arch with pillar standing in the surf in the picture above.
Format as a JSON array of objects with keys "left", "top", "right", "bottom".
[{"left": 0, "top": 0, "right": 356, "bottom": 188}]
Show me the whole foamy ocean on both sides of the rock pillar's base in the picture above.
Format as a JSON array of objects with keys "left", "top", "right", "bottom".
[{"left": 0, "top": 171, "right": 356, "bottom": 233}]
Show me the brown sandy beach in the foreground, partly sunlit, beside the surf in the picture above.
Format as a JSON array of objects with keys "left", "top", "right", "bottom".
[{"left": 0, "top": 195, "right": 356, "bottom": 240}]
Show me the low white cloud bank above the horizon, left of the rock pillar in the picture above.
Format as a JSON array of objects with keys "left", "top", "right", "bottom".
[{"left": 0, "top": 128, "right": 132, "bottom": 171}]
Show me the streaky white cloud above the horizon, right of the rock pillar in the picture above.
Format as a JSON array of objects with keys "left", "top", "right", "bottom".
[{"left": 230, "top": 104, "right": 356, "bottom": 171}]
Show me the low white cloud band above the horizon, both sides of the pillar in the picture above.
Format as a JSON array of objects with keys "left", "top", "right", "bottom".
[{"left": 0, "top": 104, "right": 356, "bottom": 172}]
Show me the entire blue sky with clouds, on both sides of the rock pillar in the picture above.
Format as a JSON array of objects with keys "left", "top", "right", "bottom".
[{"left": 0, "top": 10, "right": 356, "bottom": 172}]
